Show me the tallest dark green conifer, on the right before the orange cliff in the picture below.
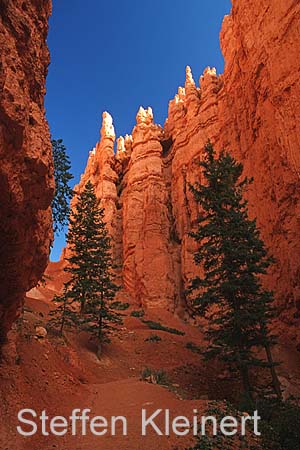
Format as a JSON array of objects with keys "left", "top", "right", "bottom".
[{"left": 187, "top": 142, "right": 281, "bottom": 398}]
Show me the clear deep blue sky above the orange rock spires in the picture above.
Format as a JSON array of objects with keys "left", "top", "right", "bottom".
[{"left": 46, "top": 0, "right": 231, "bottom": 261}]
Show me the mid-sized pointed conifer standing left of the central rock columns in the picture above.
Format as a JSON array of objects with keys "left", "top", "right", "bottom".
[{"left": 64, "top": 181, "right": 121, "bottom": 356}]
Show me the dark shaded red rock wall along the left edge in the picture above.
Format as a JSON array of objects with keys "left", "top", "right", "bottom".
[{"left": 0, "top": 0, "right": 54, "bottom": 337}]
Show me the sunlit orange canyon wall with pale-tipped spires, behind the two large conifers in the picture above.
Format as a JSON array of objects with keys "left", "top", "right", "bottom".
[{"left": 72, "top": 0, "right": 300, "bottom": 314}]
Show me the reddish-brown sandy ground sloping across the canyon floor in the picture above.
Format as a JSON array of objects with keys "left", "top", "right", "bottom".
[{"left": 0, "top": 285, "right": 300, "bottom": 450}]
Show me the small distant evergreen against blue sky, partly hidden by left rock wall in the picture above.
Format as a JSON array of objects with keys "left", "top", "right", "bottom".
[{"left": 51, "top": 139, "right": 73, "bottom": 233}]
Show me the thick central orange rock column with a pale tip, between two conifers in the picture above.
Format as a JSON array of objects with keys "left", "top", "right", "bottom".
[{"left": 121, "top": 108, "right": 177, "bottom": 307}]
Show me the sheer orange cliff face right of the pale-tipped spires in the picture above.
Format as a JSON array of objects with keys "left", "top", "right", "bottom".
[{"left": 219, "top": 0, "right": 300, "bottom": 307}]
